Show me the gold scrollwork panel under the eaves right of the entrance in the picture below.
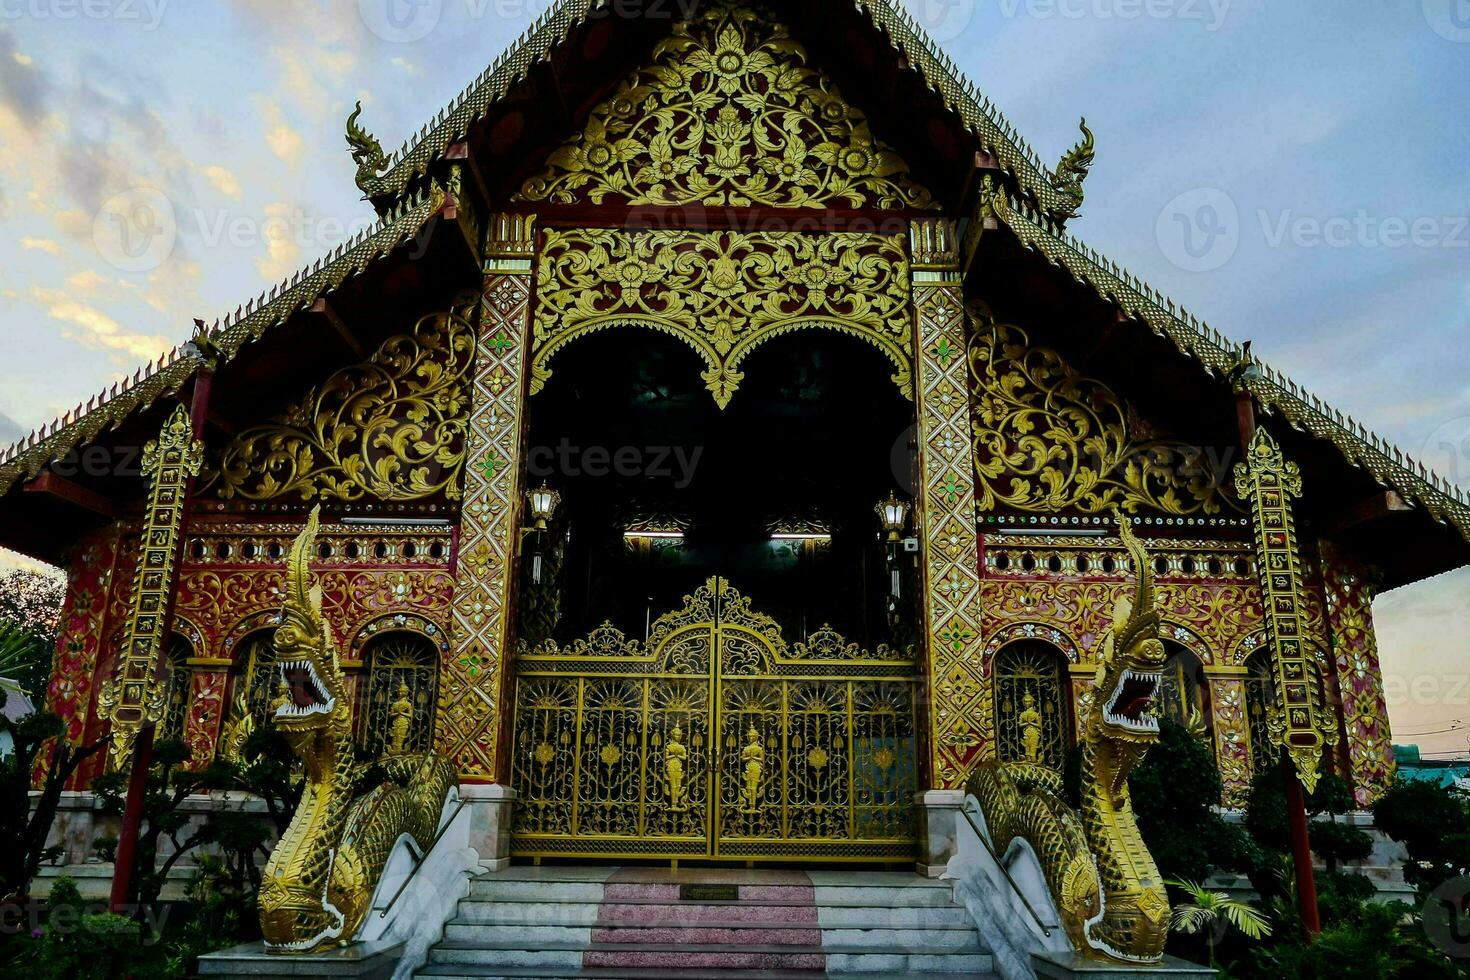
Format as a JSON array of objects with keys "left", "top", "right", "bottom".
[{"left": 969, "top": 314, "right": 1239, "bottom": 514}]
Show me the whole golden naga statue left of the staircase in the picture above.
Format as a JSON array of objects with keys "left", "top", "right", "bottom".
[{"left": 259, "top": 508, "right": 457, "bottom": 954}]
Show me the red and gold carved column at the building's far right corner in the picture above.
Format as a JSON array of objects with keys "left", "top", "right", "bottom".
[{"left": 1323, "top": 545, "right": 1397, "bottom": 807}]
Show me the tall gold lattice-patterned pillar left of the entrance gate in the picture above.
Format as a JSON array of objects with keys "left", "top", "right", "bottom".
[{"left": 435, "top": 215, "right": 535, "bottom": 783}]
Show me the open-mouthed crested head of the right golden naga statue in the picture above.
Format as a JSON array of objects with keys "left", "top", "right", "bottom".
[{"left": 1089, "top": 514, "right": 1166, "bottom": 783}]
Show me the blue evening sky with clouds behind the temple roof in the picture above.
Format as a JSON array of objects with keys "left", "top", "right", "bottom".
[{"left": 0, "top": 0, "right": 1470, "bottom": 751}]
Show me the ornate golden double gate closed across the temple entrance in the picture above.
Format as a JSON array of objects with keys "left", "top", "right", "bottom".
[{"left": 512, "top": 577, "right": 916, "bottom": 861}]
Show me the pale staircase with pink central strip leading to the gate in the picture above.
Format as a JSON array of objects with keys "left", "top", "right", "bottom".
[{"left": 416, "top": 867, "right": 992, "bottom": 980}]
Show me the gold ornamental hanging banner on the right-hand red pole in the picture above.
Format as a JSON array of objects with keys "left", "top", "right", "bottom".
[{"left": 1235, "top": 428, "right": 1332, "bottom": 792}]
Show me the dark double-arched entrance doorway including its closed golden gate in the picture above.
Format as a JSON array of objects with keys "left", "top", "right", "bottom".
[{"left": 512, "top": 331, "right": 917, "bottom": 861}]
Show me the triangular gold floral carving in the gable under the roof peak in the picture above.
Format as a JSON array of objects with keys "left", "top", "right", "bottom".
[{"left": 517, "top": 0, "right": 935, "bottom": 210}]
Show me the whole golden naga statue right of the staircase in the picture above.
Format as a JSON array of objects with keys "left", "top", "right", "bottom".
[{"left": 967, "top": 514, "right": 1169, "bottom": 964}]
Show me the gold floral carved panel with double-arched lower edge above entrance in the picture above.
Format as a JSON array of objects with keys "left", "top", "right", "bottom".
[{"left": 531, "top": 229, "right": 913, "bottom": 407}]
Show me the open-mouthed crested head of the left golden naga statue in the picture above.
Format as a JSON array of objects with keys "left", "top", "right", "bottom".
[{"left": 272, "top": 507, "right": 347, "bottom": 767}]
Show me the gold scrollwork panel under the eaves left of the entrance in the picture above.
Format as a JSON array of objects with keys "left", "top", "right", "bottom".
[{"left": 204, "top": 313, "right": 475, "bottom": 501}]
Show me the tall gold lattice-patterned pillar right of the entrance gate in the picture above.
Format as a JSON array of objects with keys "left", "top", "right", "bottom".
[{"left": 910, "top": 220, "right": 994, "bottom": 789}]
